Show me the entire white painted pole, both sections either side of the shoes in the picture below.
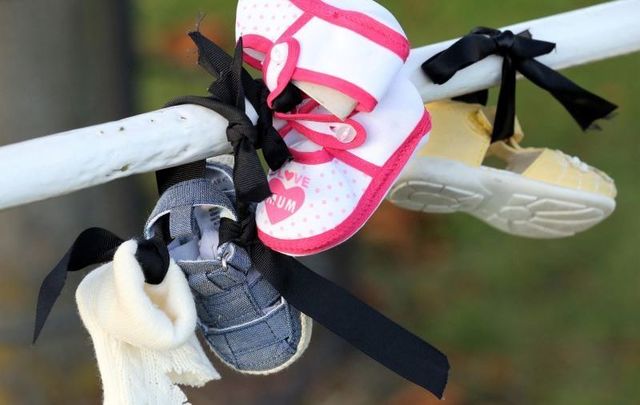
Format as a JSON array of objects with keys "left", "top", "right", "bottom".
[{"left": 0, "top": 0, "right": 640, "bottom": 209}]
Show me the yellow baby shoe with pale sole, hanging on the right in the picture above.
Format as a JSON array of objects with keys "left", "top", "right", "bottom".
[{"left": 388, "top": 101, "right": 617, "bottom": 239}]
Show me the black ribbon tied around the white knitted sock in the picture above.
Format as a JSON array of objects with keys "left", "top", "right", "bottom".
[{"left": 33, "top": 228, "right": 170, "bottom": 344}]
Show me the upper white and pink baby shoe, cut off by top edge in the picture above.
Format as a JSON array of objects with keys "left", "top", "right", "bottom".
[{"left": 236, "top": 0, "right": 411, "bottom": 118}]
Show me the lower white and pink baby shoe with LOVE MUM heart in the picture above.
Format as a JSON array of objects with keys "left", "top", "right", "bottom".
[{"left": 256, "top": 76, "right": 431, "bottom": 256}]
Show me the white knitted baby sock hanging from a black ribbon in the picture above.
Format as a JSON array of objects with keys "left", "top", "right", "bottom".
[{"left": 76, "top": 241, "right": 220, "bottom": 405}]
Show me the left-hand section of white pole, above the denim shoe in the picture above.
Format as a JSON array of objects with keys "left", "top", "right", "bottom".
[{"left": 0, "top": 105, "right": 231, "bottom": 209}]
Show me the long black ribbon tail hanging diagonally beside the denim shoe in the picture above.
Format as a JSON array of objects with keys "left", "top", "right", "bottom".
[{"left": 220, "top": 215, "right": 449, "bottom": 399}]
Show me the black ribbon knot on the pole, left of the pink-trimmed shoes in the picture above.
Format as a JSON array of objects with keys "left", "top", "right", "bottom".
[{"left": 158, "top": 31, "right": 302, "bottom": 202}]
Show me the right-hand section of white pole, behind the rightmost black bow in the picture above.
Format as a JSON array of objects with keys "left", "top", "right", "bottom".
[{"left": 404, "top": 0, "right": 640, "bottom": 102}]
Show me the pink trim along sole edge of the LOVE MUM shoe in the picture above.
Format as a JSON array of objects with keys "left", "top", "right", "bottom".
[{"left": 258, "top": 110, "right": 431, "bottom": 255}]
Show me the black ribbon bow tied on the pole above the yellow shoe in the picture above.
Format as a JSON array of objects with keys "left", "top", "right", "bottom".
[{"left": 422, "top": 27, "right": 618, "bottom": 142}]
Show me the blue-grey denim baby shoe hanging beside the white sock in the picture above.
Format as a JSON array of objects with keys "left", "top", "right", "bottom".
[{"left": 145, "top": 158, "right": 312, "bottom": 375}]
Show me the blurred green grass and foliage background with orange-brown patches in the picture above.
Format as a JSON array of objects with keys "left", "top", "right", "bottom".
[{"left": 131, "top": 0, "right": 640, "bottom": 404}]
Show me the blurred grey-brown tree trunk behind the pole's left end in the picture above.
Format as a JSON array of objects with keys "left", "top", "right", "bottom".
[{"left": 0, "top": 0, "right": 143, "bottom": 404}]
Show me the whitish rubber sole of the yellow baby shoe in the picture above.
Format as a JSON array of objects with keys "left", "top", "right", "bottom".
[{"left": 387, "top": 158, "right": 616, "bottom": 239}]
